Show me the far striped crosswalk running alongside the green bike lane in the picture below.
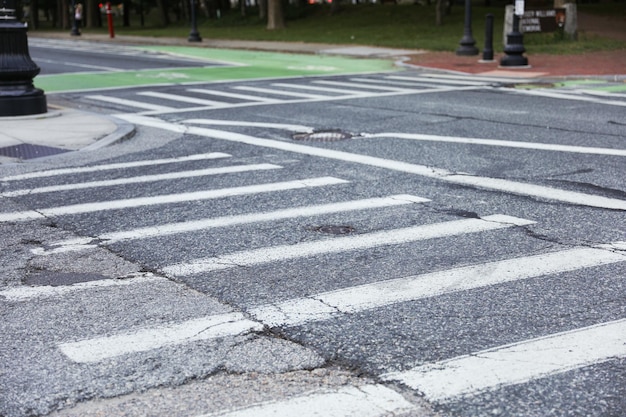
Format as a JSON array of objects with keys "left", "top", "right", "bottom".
[{"left": 81, "top": 73, "right": 502, "bottom": 115}]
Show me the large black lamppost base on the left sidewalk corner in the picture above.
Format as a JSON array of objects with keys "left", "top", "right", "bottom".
[{"left": 0, "top": 0, "right": 48, "bottom": 117}]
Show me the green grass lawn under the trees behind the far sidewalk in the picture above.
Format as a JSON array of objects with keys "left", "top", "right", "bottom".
[{"left": 33, "top": 0, "right": 626, "bottom": 54}]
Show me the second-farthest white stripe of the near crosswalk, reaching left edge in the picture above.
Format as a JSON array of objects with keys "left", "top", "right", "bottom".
[{"left": 0, "top": 164, "right": 282, "bottom": 197}]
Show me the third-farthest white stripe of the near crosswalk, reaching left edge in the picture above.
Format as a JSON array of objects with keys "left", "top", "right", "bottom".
[{"left": 0, "top": 177, "right": 348, "bottom": 222}]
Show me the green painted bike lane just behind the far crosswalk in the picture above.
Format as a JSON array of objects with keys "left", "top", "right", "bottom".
[{"left": 34, "top": 45, "right": 397, "bottom": 93}]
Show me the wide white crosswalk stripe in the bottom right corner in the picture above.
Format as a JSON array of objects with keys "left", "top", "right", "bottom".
[{"left": 382, "top": 319, "right": 626, "bottom": 402}]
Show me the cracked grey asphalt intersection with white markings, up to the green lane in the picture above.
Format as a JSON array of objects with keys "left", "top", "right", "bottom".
[{"left": 0, "top": 40, "right": 626, "bottom": 416}]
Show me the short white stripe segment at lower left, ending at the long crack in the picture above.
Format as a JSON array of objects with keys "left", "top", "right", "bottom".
[{"left": 58, "top": 313, "right": 263, "bottom": 363}]
